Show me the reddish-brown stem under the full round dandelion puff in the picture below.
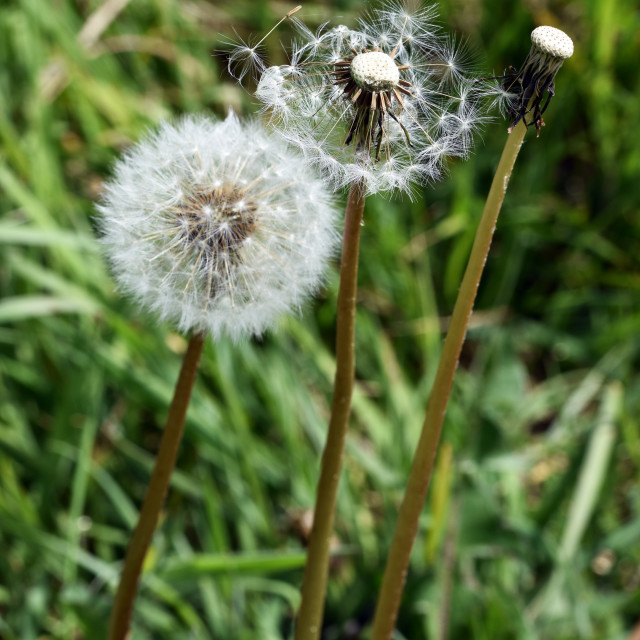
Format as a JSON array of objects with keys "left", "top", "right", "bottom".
[{"left": 108, "top": 333, "right": 205, "bottom": 640}]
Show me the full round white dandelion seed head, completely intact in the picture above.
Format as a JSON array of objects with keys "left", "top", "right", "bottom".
[{"left": 99, "top": 114, "right": 337, "bottom": 338}]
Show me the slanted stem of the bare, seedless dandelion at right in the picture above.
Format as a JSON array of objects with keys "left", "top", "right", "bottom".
[{"left": 371, "top": 121, "right": 527, "bottom": 640}]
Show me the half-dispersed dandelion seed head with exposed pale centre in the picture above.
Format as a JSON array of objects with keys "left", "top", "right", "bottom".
[{"left": 240, "top": 3, "right": 483, "bottom": 193}]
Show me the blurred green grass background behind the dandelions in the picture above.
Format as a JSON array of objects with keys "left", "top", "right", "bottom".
[{"left": 0, "top": 0, "right": 640, "bottom": 640}]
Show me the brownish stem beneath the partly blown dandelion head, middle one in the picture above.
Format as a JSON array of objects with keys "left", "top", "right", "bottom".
[{"left": 295, "top": 182, "right": 365, "bottom": 640}]
